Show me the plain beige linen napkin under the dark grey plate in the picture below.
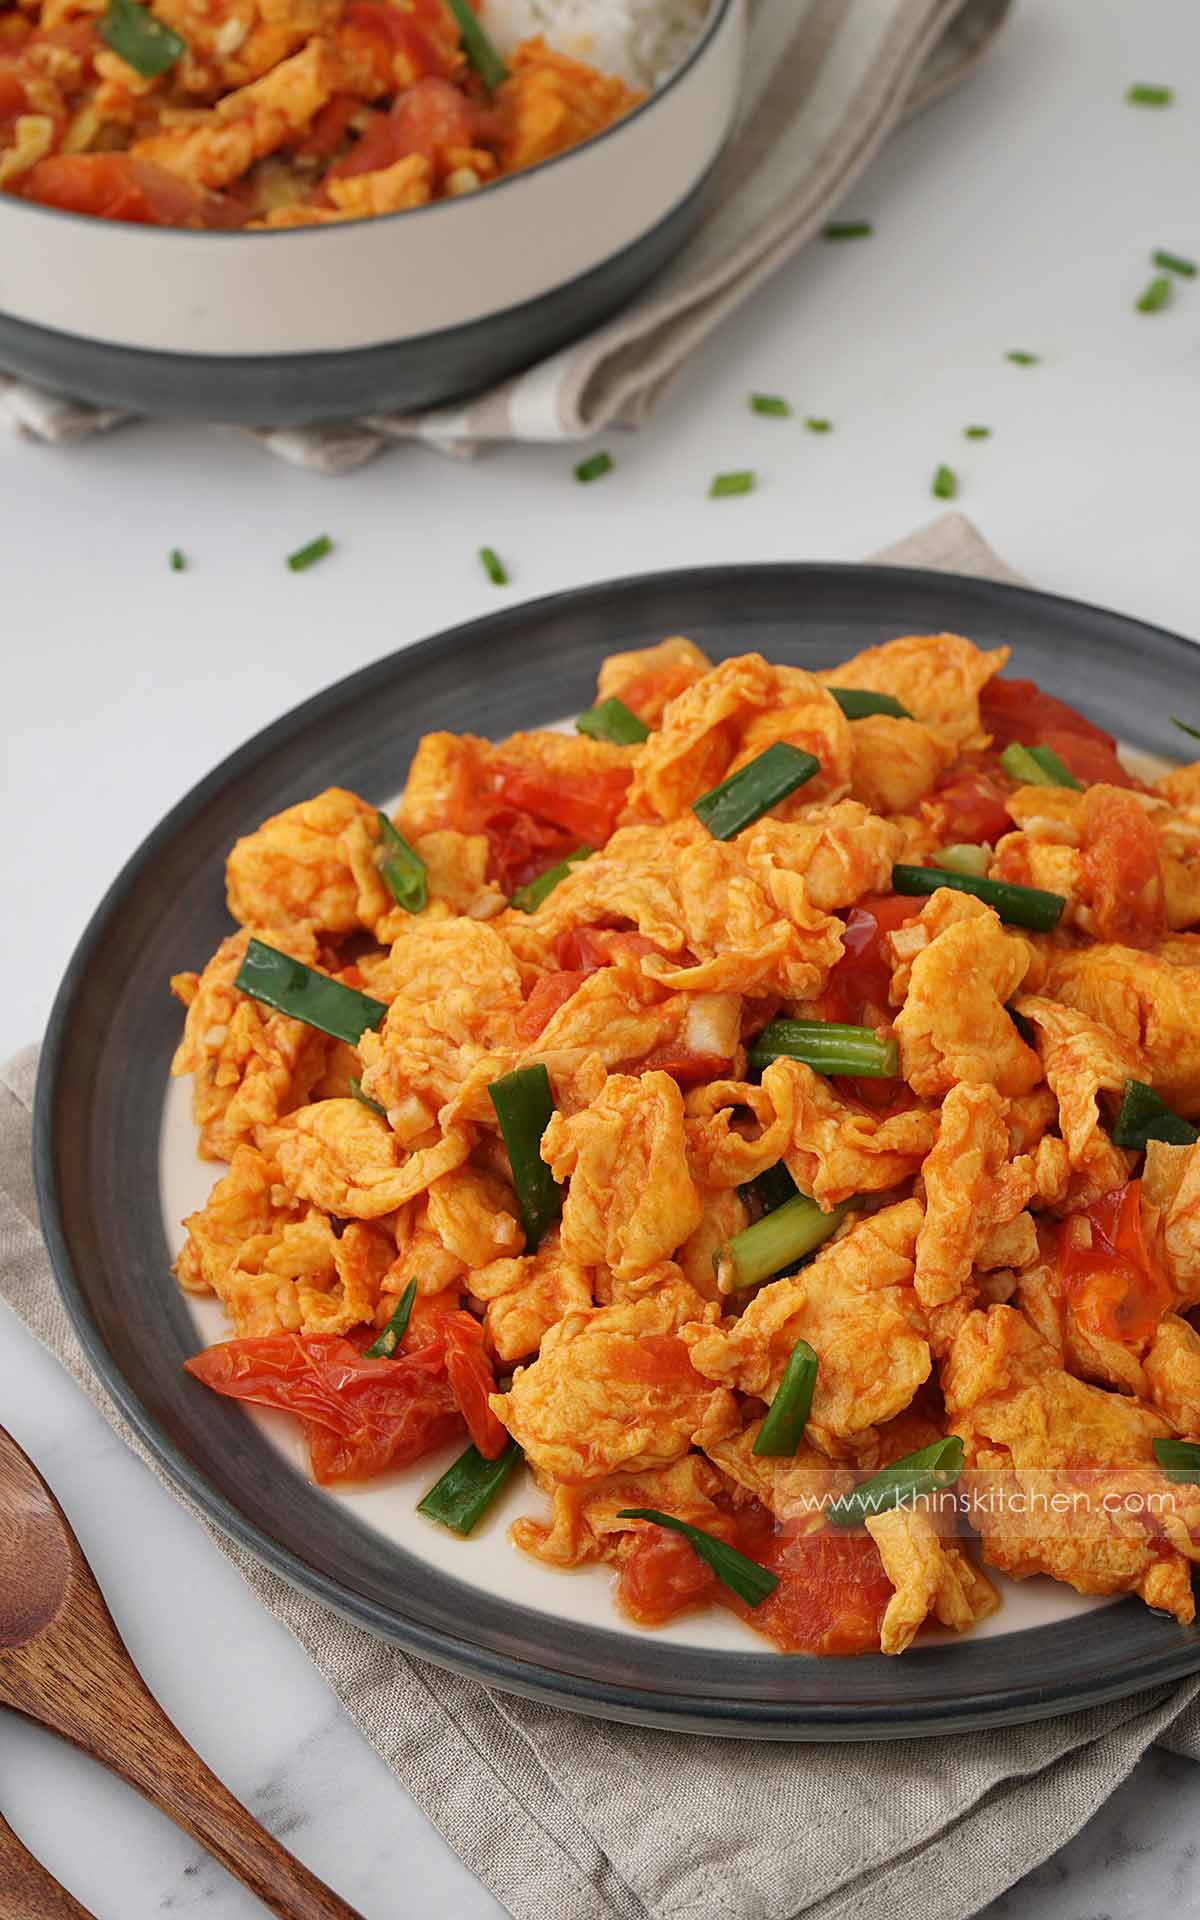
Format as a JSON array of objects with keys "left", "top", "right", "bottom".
[{"left": 0, "top": 515, "right": 1200, "bottom": 1920}]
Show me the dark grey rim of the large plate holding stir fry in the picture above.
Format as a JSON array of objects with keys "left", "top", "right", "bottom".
[{"left": 35, "top": 564, "right": 1200, "bottom": 1740}]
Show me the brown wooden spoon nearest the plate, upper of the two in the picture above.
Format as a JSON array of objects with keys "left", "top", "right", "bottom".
[{"left": 0, "top": 1427, "right": 363, "bottom": 1920}]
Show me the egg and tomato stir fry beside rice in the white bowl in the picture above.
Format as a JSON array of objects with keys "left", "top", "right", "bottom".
[{"left": 0, "top": 0, "right": 639, "bottom": 228}]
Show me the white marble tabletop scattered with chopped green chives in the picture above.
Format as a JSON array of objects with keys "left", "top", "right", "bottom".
[{"left": 0, "top": 0, "right": 1200, "bottom": 1920}]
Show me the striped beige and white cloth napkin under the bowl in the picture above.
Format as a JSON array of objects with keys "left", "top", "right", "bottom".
[{"left": 0, "top": 0, "right": 1012, "bottom": 472}]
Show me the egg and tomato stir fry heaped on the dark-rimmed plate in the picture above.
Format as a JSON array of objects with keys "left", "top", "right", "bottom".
[{"left": 173, "top": 634, "right": 1200, "bottom": 1653}]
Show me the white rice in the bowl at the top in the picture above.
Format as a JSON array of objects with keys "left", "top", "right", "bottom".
[{"left": 482, "top": 0, "right": 712, "bottom": 86}]
